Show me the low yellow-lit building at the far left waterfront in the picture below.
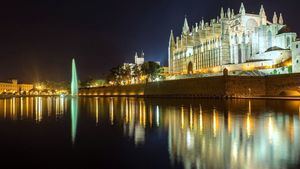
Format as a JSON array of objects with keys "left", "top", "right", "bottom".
[{"left": 0, "top": 79, "right": 33, "bottom": 94}]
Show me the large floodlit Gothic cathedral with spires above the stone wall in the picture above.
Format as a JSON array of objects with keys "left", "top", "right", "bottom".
[{"left": 168, "top": 4, "right": 300, "bottom": 74}]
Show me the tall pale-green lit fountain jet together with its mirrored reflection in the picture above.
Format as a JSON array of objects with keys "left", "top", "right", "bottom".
[{"left": 71, "top": 59, "right": 78, "bottom": 144}]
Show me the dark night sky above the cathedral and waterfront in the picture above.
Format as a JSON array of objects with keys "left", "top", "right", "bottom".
[{"left": 0, "top": 0, "right": 300, "bottom": 82}]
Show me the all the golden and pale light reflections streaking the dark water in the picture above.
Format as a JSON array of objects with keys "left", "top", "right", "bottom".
[{"left": 0, "top": 97, "right": 300, "bottom": 169}]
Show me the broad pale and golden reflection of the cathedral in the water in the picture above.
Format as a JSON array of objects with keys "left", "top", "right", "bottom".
[{"left": 168, "top": 101, "right": 300, "bottom": 169}]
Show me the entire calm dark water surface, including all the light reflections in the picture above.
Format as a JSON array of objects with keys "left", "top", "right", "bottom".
[{"left": 0, "top": 97, "right": 300, "bottom": 169}]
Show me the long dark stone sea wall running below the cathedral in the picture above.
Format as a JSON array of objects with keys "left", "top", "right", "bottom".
[{"left": 80, "top": 74, "right": 300, "bottom": 98}]
